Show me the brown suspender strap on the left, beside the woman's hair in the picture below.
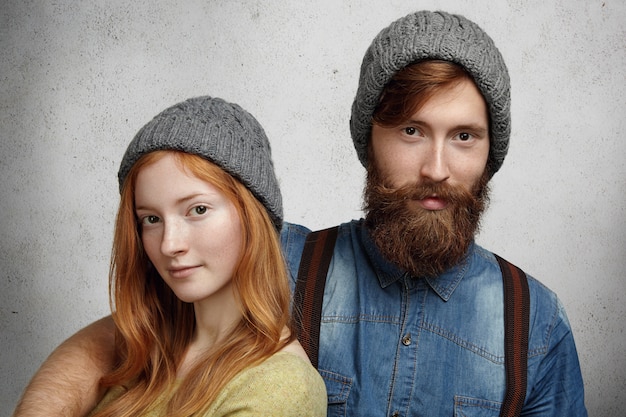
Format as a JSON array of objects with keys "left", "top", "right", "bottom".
[{"left": 293, "top": 227, "right": 338, "bottom": 368}]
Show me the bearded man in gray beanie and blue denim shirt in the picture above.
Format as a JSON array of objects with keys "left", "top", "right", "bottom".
[{"left": 13, "top": 12, "right": 587, "bottom": 416}]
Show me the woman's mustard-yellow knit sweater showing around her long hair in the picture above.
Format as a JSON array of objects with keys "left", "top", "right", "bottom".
[{"left": 90, "top": 352, "right": 327, "bottom": 417}]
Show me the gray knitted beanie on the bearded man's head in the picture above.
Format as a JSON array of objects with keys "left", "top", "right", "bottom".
[{"left": 350, "top": 11, "right": 511, "bottom": 175}]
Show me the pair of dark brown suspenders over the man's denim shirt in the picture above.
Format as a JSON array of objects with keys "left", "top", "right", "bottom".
[{"left": 293, "top": 227, "right": 530, "bottom": 417}]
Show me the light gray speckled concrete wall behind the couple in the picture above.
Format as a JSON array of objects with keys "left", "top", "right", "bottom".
[{"left": 0, "top": 0, "right": 626, "bottom": 417}]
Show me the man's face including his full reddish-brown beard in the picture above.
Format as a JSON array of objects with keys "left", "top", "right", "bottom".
[{"left": 365, "top": 80, "right": 489, "bottom": 276}]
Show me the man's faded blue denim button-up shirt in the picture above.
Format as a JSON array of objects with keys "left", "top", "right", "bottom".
[{"left": 281, "top": 220, "right": 587, "bottom": 417}]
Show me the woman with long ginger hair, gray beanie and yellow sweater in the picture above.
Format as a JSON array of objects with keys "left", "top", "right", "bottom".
[{"left": 90, "top": 97, "right": 326, "bottom": 416}]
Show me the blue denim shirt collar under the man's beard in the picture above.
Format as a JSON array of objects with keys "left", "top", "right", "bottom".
[{"left": 361, "top": 220, "right": 475, "bottom": 301}]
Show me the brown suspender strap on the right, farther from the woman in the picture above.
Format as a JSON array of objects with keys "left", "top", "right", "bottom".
[{"left": 495, "top": 255, "right": 530, "bottom": 417}]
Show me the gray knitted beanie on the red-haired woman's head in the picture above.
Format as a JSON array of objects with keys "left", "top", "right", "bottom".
[{"left": 117, "top": 96, "right": 283, "bottom": 230}]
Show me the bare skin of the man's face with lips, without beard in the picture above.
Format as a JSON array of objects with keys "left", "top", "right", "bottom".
[{"left": 371, "top": 80, "right": 489, "bottom": 210}]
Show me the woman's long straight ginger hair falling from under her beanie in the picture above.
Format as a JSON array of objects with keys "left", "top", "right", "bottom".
[{"left": 95, "top": 150, "right": 295, "bottom": 417}]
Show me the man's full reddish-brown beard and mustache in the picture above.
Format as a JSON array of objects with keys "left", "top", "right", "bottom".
[{"left": 364, "top": 164, "right": 489, "bottom": 277}]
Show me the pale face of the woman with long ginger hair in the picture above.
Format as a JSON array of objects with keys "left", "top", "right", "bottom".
[{"left": 135, "top": 154, "right": 242, "bottom": 304}]
